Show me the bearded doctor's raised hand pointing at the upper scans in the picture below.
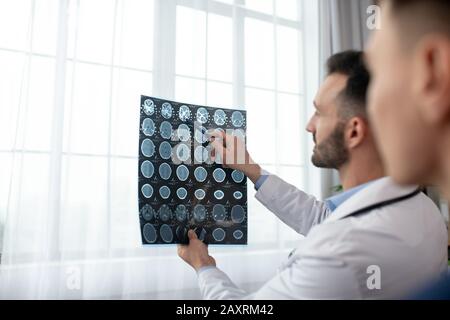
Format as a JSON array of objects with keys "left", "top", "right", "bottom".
[{"left": 209, "top": 130, "right": 261, "bottom": 183}]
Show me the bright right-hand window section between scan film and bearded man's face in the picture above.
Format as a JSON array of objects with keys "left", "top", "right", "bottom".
[{"left": 174, "top": 0, "right": 312, "bottom": 248}]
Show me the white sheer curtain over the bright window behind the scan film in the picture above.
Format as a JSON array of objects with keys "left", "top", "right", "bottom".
[{"left": 0, "top": 0, "right": 320, "bottom": 299}]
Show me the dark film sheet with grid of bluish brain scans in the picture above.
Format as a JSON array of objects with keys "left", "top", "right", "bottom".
[{"left": 139, "top": 96, "right": 248, "bottom": 245}]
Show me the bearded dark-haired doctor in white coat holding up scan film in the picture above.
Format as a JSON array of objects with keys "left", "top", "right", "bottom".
[{"left": 178, "top": 51, "right": 447, "bottom": 299}]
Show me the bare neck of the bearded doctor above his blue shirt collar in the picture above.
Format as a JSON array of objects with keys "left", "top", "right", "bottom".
[{"left": 338, "top": 161, "right": 385, "bottom": 190}]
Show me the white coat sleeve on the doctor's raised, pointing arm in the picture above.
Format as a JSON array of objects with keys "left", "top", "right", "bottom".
[{"left": 255, "top": 174, "right": 331, "bottom": 235}]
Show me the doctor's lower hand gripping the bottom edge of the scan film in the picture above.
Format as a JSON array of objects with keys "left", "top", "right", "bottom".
[{"left": 178, "top": 230, "right": 216, "bottom": 271}]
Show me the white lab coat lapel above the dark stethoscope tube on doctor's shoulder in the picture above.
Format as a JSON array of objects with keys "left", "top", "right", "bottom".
[{"left": 324, "top": 177, "right": 418, "bottom": 223}]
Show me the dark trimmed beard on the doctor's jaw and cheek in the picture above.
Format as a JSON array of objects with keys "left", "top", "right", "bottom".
[{"left": 311, "top": 122, "right": 349, "bottom": 169}]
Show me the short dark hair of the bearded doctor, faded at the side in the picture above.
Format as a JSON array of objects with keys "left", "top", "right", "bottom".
[{"left": 327, "top": 50, "right": 370, "bottom": 118}]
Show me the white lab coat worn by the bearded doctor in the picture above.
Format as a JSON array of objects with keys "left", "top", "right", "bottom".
[{"left": 198, "top": 175, "right": 447, "bottom": 299}]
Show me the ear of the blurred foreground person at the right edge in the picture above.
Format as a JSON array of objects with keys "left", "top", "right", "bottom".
[{"left": 412, "top": 34, "right": 450, "bottom": 125}]
